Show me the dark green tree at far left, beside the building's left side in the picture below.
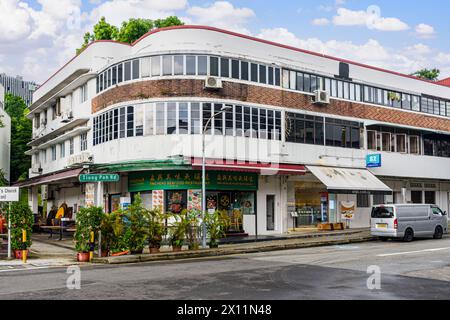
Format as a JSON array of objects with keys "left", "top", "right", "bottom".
[{"left": 5, "top": 93, "right": 33, "bottom": 181}]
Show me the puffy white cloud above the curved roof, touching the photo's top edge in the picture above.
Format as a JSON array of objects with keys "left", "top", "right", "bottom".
[{"left": 187, "top": 1, "right": 255, "bottom": 34}]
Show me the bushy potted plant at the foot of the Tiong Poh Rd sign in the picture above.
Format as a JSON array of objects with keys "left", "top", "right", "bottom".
[{"left": 74, "top": 207, "right": 103, "bottom": 262}]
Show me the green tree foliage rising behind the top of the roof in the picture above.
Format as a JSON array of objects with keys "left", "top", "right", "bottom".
[{"left": 77, "top": 16, "right": 184, "bottom": 54}]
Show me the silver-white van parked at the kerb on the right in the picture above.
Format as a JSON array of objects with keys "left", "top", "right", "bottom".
[{"left": 370, "top": 204, "right": 448, "bottom": 242}]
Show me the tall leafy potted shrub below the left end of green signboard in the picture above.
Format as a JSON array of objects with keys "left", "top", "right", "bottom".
[{"left": 125, "top": 194, "right": 148, "bottom": 254}]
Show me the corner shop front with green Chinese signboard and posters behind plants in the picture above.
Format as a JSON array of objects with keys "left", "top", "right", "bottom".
[{"left": 128, "top": 170, "right": 258, "bottom": 235}]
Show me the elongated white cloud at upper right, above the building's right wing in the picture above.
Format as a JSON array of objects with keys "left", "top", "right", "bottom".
[{"left": 333, "top": 6, "right": 409, "bottom": 31}]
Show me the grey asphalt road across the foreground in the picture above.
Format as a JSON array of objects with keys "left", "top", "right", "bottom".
[{"left": 0, "top": 237, "right": 450, "bottom": 300}]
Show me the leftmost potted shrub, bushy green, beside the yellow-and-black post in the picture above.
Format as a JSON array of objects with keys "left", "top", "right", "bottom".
[{"left": 11, "top": 202, "right": 34, "bottom": 259}]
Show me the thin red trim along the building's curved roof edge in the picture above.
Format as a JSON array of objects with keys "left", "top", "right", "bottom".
[{"left": 36, "top": 25, "right": 448, "bottom": 95}]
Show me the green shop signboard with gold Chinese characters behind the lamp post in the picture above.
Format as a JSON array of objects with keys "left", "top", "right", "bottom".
[{"left": 128, "top": 170, "right": 258, "bottom": 192}]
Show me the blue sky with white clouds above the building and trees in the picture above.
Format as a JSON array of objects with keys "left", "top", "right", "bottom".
[{"left": 0, "top": 0, "right": 450, "bottom": 83}]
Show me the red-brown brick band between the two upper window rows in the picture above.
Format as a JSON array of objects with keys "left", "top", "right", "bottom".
[{"left": 92, "top": 79, "right": 450, "bottom": 132}]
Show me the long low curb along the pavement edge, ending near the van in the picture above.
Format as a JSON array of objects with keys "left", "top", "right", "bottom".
[{"left": 92, "top": 236, "right": 376, "bottom": 264}]
